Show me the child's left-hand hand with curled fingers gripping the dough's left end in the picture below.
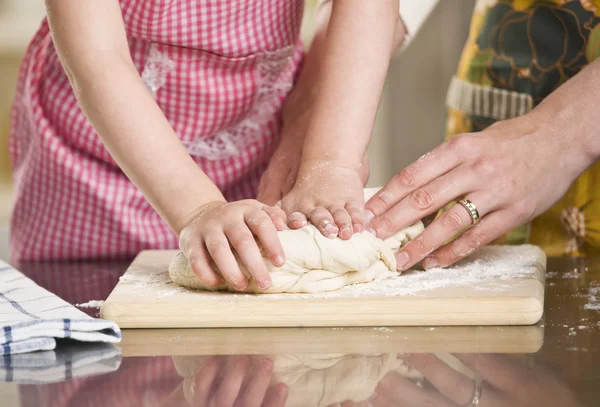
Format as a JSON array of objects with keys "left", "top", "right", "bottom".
[{"left": 179, "top": 200, "right": 285, "bottom": 291}]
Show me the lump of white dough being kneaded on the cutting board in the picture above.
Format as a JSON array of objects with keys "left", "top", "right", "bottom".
[{"left": 169, "top": 190, "right": 423, "bottom": 293}]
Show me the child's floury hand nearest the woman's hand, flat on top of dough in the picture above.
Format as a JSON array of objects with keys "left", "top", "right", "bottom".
[{"left": 280, "top": 161, "right": 365, "bottom": 239}]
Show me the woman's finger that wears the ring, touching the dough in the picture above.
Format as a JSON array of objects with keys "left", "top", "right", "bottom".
[{"left": 396, "top": 194, "right": 488, "bottom": 270}]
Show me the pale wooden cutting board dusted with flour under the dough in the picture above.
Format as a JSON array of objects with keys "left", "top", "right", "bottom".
[{"left": 101, "top": 246, "right": 546, "bottom": 328}]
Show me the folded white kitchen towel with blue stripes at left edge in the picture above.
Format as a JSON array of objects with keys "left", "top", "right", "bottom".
[{"left": 0, "top": 261, "right": 121, "bottom": 355}]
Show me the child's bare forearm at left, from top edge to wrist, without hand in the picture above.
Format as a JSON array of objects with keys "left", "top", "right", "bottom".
[{"left": 46, "top": 0, "right": 223, "bottom": 233}]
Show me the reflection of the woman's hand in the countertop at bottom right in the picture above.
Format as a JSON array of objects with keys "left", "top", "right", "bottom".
[{"left": 370, "top": 354, "right": 582, "bottom": 407}]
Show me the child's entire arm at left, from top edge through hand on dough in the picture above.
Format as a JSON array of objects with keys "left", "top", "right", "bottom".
[{"left": 46, "top": 0, "right": 282, "bottom": 288}]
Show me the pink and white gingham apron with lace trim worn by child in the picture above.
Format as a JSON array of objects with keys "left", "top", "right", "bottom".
[{"left": 10, "top": 0, "right": 304, "bottom": 261}]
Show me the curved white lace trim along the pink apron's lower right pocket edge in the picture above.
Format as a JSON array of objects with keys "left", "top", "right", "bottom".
[{"left": 184, "top": 45, "right": 295, "bottom": 160}]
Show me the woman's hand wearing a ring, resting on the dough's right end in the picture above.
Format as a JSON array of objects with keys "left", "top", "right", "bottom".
[{"left": 366, "top": 115, "right": 591, "bottom": 270}]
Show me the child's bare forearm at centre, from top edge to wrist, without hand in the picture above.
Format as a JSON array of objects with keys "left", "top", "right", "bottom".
[{"left": 301, "top": 0, "right": 401, "bottom": 168}]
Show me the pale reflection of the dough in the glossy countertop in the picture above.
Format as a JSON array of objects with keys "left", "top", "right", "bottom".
[{"left": 173, "top": 353, "right": 423, "bottom": 407}]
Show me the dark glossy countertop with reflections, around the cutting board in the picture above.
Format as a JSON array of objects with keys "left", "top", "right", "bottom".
[{"left": 0, "top": 236, "right": 600, "bottom": 407}]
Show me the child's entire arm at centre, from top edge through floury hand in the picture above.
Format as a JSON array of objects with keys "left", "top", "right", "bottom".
[{"left": 282, "top": 0, "right": 402, "bottom": 238}]
